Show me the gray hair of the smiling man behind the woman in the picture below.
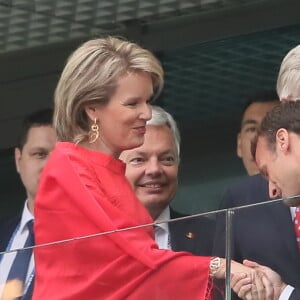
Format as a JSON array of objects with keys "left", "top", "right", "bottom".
[{"left": 147, "top": 105, "right": 181, "bottom": 159}]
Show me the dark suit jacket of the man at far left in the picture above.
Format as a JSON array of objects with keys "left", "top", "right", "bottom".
[{"left": 0, "top": 215, "right": 34, "bottom": 300}]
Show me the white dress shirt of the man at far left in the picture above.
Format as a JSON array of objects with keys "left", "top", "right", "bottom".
[{"left": 0, "top": 201, "right": 34, "bottom": 299}]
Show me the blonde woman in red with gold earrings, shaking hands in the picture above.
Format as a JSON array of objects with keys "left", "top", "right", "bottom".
[{"left": 33, "top": 37, "right": 262, "bottom": 300}]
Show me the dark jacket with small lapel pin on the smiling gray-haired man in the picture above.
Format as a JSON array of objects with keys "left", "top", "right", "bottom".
[{"left": 169, "top": 208, "right": 215, "bottom": 256}]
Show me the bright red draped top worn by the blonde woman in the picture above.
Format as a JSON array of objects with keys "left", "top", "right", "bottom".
[{"left": 33, "top": 143, "right": 211, "bottom": 300}]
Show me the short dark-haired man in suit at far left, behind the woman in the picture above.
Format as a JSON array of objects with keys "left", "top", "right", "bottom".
[{"left": 0, "top": 109, "right": 56, "bottom": 300}]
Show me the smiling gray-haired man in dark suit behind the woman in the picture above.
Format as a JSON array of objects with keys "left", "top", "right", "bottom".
[{"left": 120, "top": 106, "right": 215, "bottom": 255}]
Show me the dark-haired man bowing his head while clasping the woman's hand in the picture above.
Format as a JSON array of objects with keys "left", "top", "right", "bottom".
[{"left": 234, "top": 101, "right": 300, "bottom": 300}]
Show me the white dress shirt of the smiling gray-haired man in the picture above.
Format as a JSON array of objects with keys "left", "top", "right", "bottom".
[{"left": 154, "top": 206, "right": 171, "bottom": 249}]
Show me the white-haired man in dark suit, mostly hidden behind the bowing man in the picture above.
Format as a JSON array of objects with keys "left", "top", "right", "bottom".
[{"left": 214, "top": 45, "right": 300, "bottom": 300}]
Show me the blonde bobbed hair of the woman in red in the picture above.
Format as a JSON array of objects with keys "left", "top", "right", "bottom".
[{"left": 54, "top": 37, "right": 164, "bottom": 143}]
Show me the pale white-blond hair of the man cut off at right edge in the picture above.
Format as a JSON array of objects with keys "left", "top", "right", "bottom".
[{"left": 277, "top": 45, "right": 300, "bottom": 100}]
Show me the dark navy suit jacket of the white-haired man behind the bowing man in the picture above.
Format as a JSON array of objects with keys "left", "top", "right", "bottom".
[{"left": 213, "top": 175, "right": 300, "bottom": 299}]
